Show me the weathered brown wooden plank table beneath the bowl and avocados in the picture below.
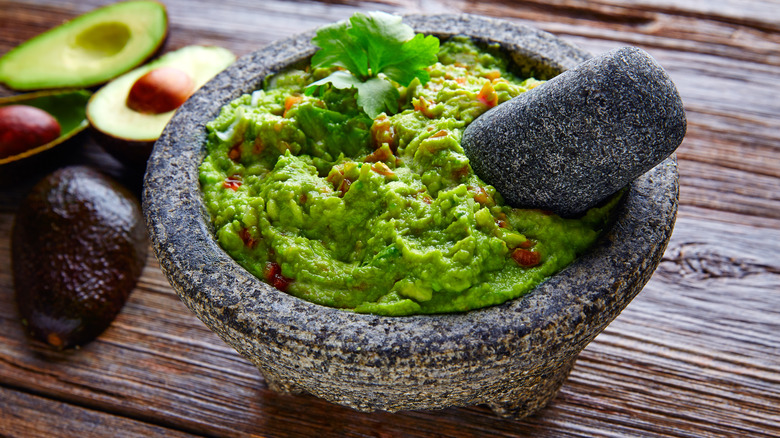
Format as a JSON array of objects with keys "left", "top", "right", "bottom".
[{"left": 0, "top": 0, "right": 780, "bottom": 437}]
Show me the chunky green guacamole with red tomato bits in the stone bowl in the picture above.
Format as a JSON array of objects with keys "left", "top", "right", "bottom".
[{"left": 200, "top": 38, "right": 616, "bottom": 315}]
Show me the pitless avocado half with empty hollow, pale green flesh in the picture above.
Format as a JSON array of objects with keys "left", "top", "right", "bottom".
[{"left": 0, "top": 0, "right": 168, "bottom": 90}]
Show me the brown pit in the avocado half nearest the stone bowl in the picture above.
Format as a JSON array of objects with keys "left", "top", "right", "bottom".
[{"left": 127, "top": 67, "right": 195, "bottom": 114}]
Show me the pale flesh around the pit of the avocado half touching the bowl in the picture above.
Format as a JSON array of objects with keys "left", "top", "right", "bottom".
[{"left": 87, "top": 46, "right": 235, "bottom": 142}]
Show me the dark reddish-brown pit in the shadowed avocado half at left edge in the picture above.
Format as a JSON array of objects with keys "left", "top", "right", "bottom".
[{"left": 0, "top": 105, "right": 60, "bottom": 158}]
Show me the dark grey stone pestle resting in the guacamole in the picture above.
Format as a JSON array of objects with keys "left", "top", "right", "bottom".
[{"left": 462, "top": 47, "right": 686, "bottom": 217}]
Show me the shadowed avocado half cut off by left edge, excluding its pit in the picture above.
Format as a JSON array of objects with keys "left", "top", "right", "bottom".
[{"left": 0, "top": 90, "right": 92, "bottom": 165}]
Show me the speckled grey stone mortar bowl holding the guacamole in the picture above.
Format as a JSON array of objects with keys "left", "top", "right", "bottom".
[{"left": 143, "top": 15, "right": 678, "bottom": 417}]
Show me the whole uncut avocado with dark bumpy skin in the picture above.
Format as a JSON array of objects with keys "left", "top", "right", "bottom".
[{"left": 11, "top": 166, "right": 148, "bottom": 349}]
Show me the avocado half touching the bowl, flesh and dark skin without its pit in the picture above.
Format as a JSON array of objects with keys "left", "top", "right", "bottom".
[{"left": 87, "top": 46, "right": 236, "bottom": 165}]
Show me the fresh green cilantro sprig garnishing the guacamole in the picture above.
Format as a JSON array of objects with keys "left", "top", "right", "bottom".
[{"left": 306, "top": 12, "right": 439, "bottom": 118}]
